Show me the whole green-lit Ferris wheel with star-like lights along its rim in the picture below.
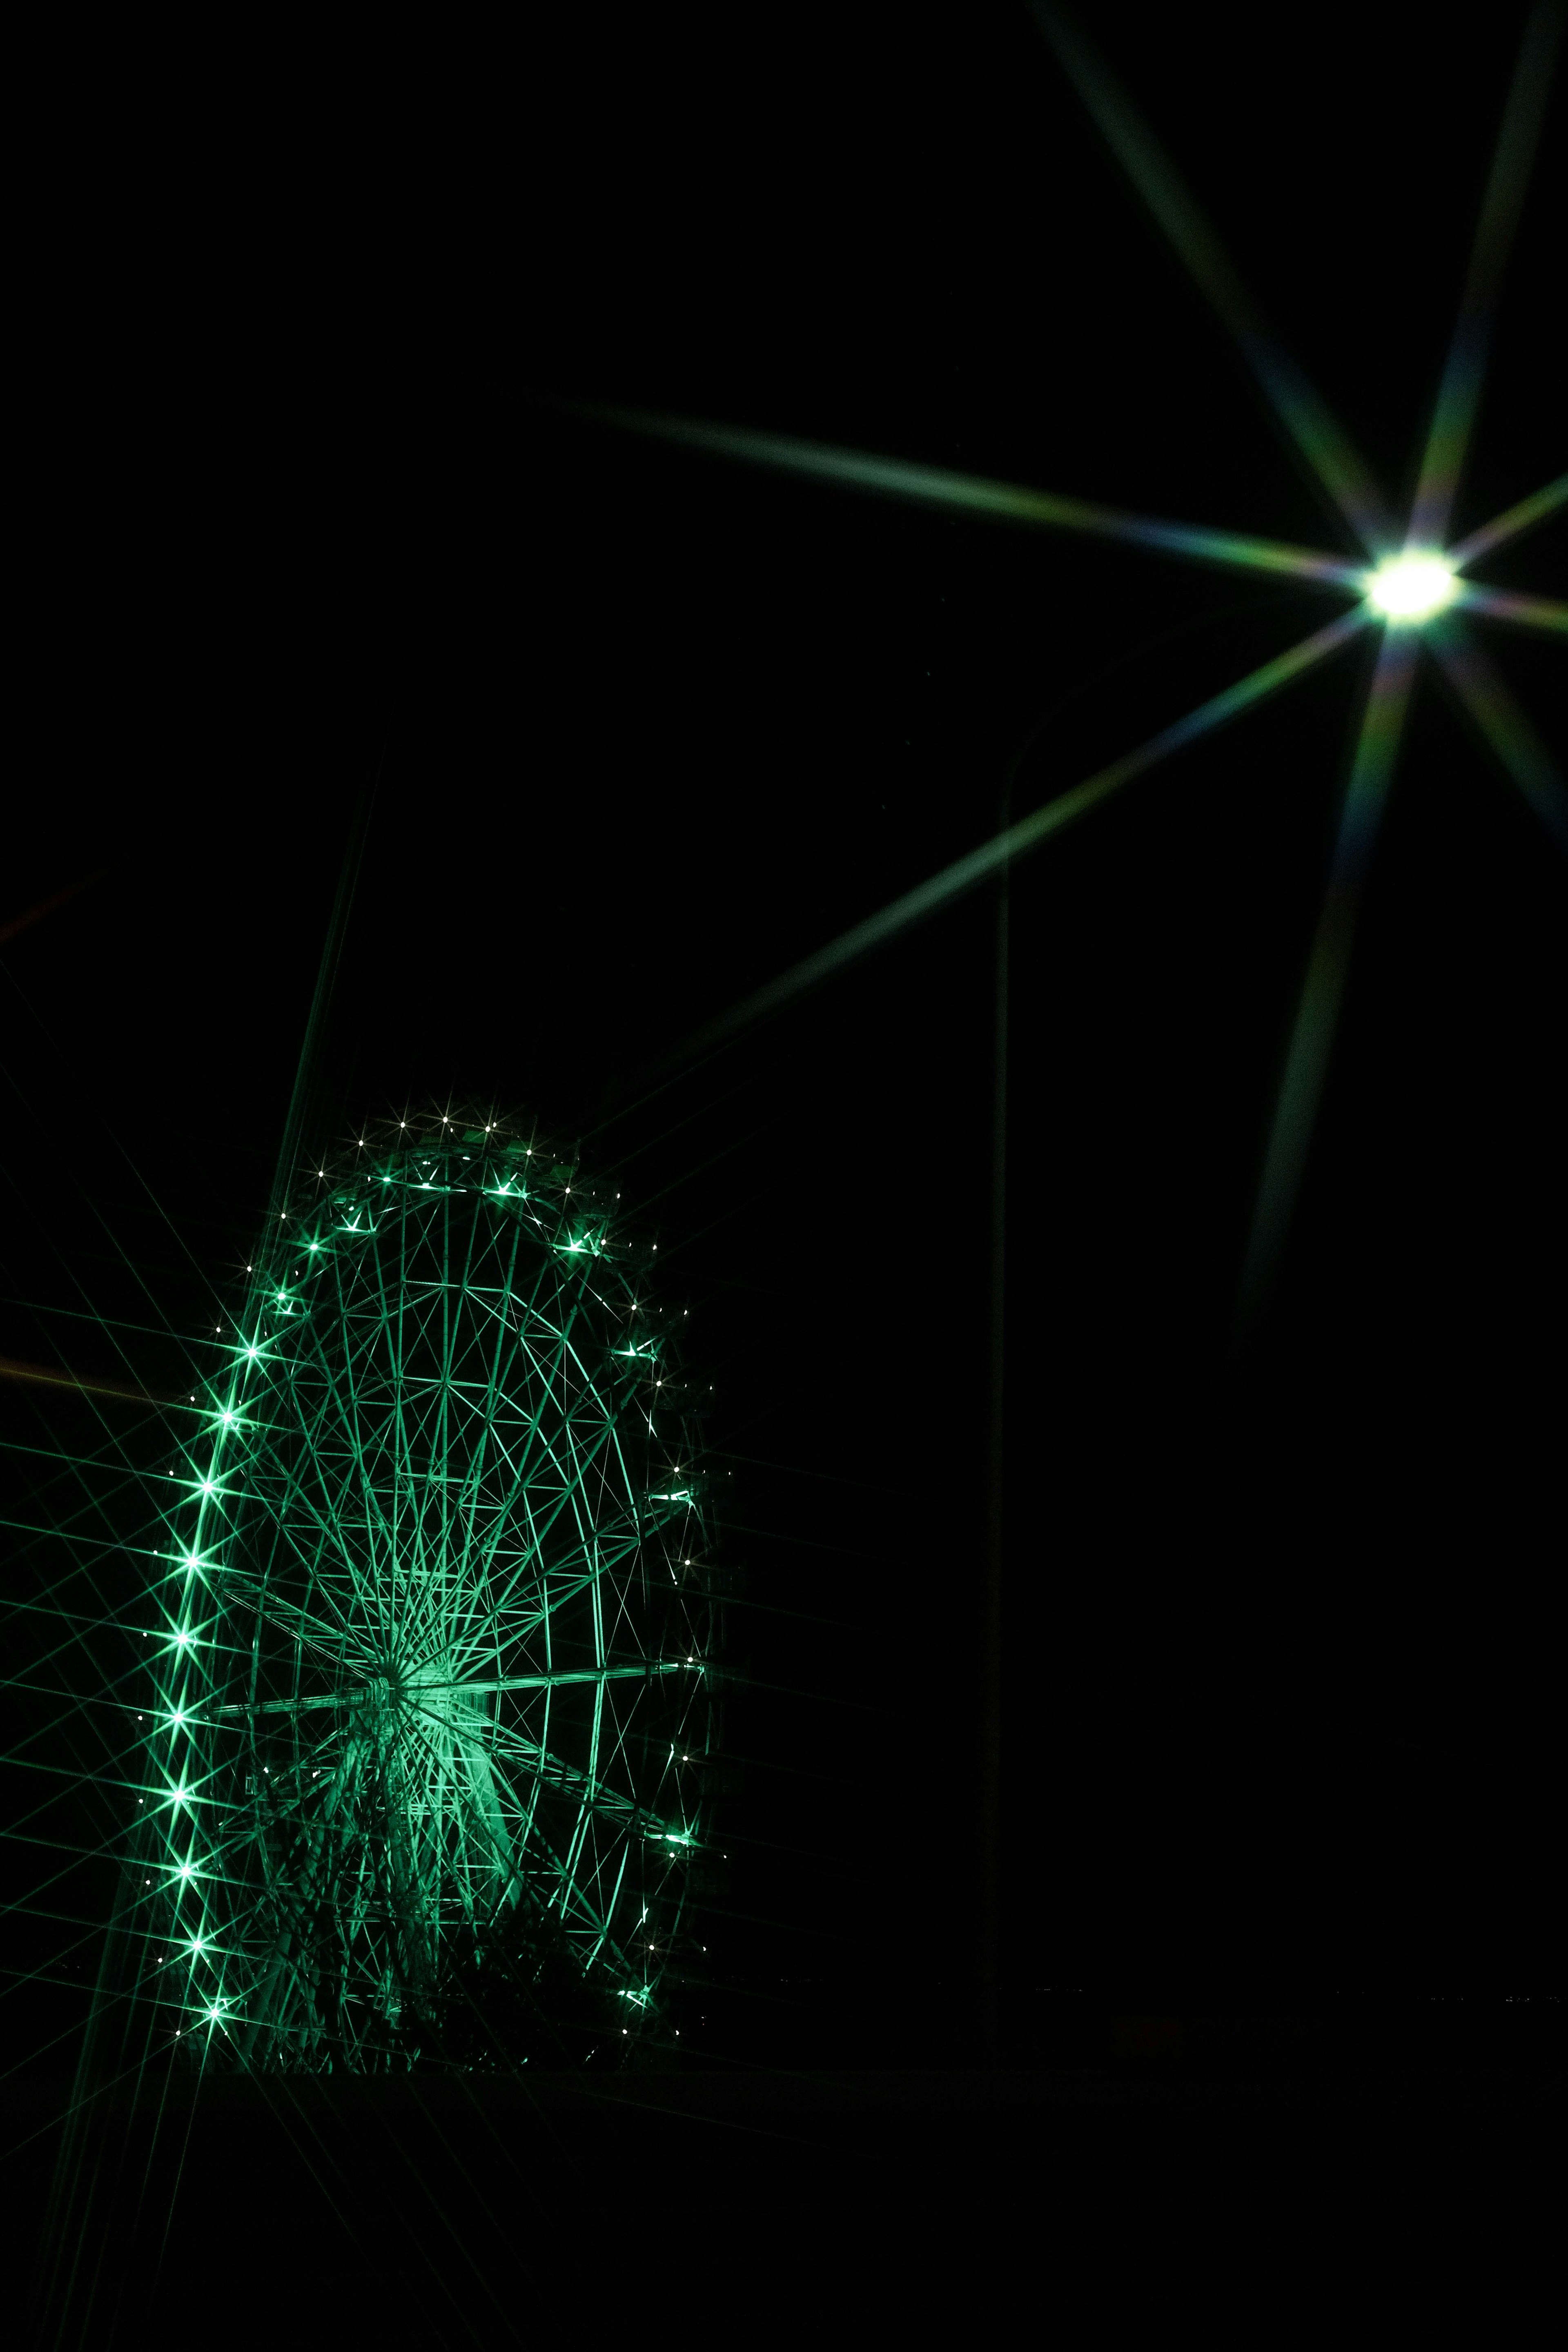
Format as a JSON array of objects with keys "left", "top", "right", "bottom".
[{"left": 139, "top": 1115, "right": 712, "bottom": 2070}]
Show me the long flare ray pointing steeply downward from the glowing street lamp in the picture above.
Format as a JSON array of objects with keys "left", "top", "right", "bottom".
[{"left": 1241, "top": 628, "right": 1418, "bottom": 1327}]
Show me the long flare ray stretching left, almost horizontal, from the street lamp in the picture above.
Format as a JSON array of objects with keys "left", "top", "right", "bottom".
[{"left": 574, "top": 407, "right": 1363, "bottom": 590}]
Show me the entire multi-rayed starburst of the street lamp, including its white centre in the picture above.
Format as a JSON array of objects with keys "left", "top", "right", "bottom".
[{"left": 552, "top": 0, "right": 1568, "bottom": 1322}]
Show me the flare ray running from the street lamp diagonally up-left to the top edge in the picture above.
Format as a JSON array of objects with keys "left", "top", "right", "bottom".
[{"left": 1034, "top": 0, "right": 1396, "bottom": 555}]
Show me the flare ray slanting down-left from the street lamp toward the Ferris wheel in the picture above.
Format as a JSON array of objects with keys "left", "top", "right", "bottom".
[{"left": 675, "top": 607, "right": 1375, "bottom": 1061}]
